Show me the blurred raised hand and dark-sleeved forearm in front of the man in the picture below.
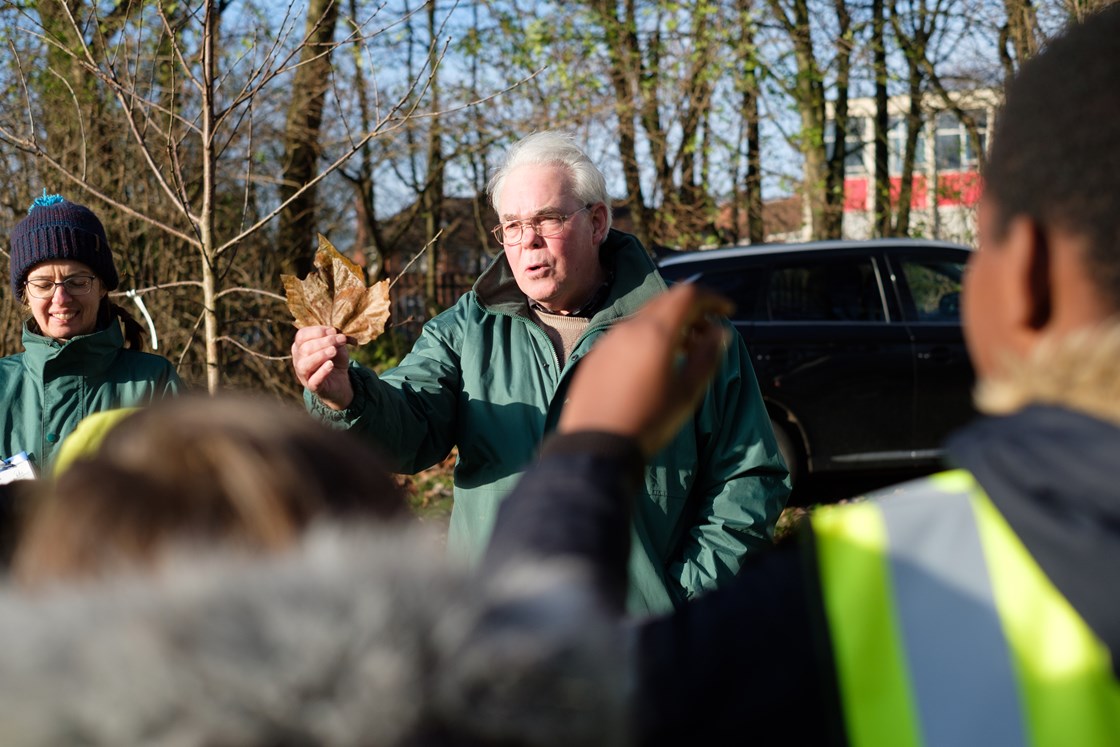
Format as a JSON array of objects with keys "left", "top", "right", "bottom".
[{"left": 486, "top": 286, "right": 729, "bottom": 607}]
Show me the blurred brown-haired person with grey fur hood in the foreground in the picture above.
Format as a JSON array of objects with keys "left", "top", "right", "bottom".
[{"left": 0, "top": 396, "right": 628, "bottom": 747}]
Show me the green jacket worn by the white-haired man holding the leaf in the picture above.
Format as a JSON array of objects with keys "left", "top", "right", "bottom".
[{"left": 306, "top": 231, "right": 788, "bottom": 613}]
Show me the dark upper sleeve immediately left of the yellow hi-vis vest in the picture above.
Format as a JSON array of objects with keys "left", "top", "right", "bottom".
[{"left": 633, "top": 536, "right": 847, "bottom": 746}]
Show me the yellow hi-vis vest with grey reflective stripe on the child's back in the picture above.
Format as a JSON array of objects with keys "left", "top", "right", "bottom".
[{"left": 812, "top": 470, "right": 1120, "bottom": 747}]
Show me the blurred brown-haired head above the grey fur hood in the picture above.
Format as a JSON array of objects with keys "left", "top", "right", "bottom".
[{"left": 13, "top": 395, "right": 408, "bottom": 585}]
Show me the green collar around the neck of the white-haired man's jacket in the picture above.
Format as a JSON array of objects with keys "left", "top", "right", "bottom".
[{"left": 474, "top": 228, "right": 665, "bottom": 324}]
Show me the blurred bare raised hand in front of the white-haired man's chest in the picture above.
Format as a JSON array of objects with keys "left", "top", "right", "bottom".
[{"left": 557, "top": 283, "right": 732, "bottom": 457}]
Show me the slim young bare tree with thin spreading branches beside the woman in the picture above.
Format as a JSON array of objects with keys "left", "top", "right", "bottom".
[{"left": 0, "top": 0, "right": 452, "bottom": 392}]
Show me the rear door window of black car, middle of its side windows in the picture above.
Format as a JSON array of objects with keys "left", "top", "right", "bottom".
[{"left": 766, "top": 259, "right": 886, "bottom": 321}]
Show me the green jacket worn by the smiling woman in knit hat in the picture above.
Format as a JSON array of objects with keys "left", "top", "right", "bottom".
[{"left": 0, "top": 320, "right": 183, "bottom": 474}]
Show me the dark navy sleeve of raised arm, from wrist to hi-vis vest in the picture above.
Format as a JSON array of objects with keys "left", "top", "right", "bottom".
[{"left": 483, "top": 433, "right": 844, "bottom": 745}]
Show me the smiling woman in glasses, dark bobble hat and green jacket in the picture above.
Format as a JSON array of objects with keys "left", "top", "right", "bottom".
[{"left": 0, "top": 190, "right": 183, "bottom": 472}]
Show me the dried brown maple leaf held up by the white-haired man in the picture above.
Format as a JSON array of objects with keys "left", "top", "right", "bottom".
[{"left": 280, "top": 234, "right": 390, "bottom": 345}]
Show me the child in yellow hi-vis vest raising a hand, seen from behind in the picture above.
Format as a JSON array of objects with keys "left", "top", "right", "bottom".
[{"left": 487, "top": 6, "right": 1120, "bottom": 747}]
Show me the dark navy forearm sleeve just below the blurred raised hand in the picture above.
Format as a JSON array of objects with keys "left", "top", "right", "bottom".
[{"left": 483, "top": 432, "right": 643, "bottom": 611}]
